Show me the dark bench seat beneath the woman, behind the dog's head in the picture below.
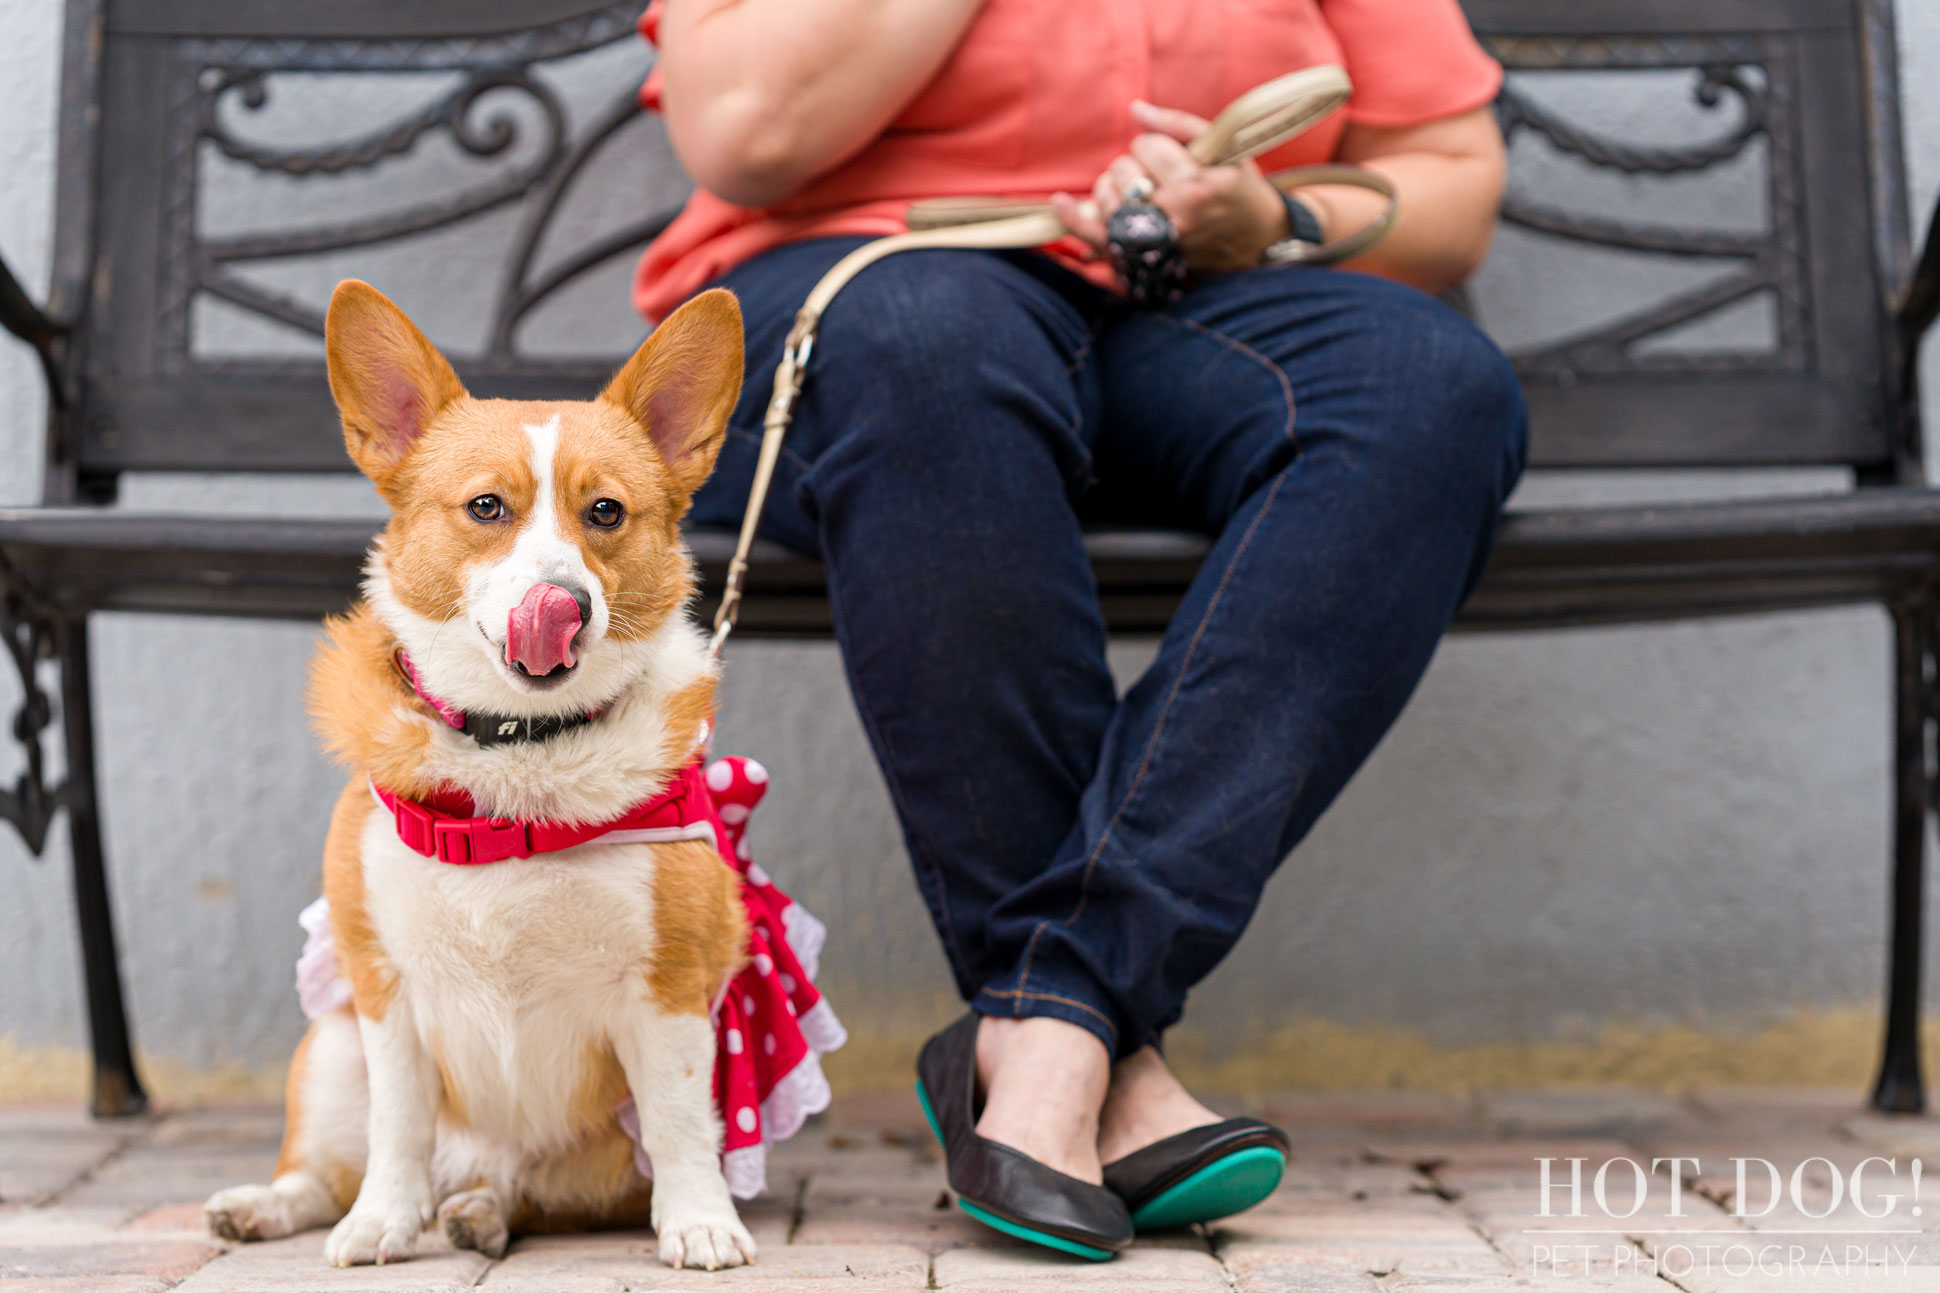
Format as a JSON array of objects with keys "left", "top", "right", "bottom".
[{"left": 11, "top": 487, "right": 1940, "bottom": 637}]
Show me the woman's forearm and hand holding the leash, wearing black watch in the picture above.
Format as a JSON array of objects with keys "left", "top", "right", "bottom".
[{"left": 1057, "top": 103, "right": 1505, "bottom": 291}]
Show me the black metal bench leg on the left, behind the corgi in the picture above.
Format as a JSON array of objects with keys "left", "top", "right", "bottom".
[{"left": 58, "top": 617, "right": 147, "bottom": 1118}]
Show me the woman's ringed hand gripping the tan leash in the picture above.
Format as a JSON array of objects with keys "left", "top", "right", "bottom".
[{"left": 1051, "top": 101, "right": 1288, "bottom": 274}]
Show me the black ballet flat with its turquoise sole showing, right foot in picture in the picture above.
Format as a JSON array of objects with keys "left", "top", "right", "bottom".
[{"left": 1104, "top": 1118, "right": 1292, "bottom": 1231}]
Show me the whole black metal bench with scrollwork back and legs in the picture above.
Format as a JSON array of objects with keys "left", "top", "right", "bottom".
[{"left": 0, "top": 0, "right": 1940, "bottom": 1114}]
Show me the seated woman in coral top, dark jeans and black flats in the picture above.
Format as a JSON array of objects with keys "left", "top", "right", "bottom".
[{"left": 636, "top": 0, "right": 1527, "bottom": 1256}]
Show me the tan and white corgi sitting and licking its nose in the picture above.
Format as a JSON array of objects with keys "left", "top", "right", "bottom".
[{"left": 206, "top": 282, "right": 755, "bottom": 1270}]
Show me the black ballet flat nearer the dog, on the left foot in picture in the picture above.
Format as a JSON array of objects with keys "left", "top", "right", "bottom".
[{"left": 916, "top": 1013, "right": 1133, "bottom": 1262}]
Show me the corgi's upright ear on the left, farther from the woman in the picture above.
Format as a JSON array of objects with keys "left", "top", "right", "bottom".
[{"left": 324, "top": 280, "right": 466, "bottom": 489}]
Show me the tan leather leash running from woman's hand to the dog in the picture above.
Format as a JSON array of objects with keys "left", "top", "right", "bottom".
[{"left": 712, "top": 64, "right": 1399, "bottom": 656}]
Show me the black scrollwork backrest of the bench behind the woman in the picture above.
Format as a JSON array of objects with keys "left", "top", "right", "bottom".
[{"left": 45, "top": 0, "right": 1905, "bottom": 491}]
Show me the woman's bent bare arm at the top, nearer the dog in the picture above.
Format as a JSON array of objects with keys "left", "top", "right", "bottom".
[{"left": 660, "top": 0, "right": 984, "bottom": 206}]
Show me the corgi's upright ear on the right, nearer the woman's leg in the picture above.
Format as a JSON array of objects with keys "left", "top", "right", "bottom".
[{"left": 599, "top": 287, "right": 741, "bottom": 493}]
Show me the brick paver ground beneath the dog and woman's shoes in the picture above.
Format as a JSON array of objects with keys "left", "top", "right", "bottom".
[{"left": 0, "top": 1089, "right": 1940, "bottom": 1293}]
